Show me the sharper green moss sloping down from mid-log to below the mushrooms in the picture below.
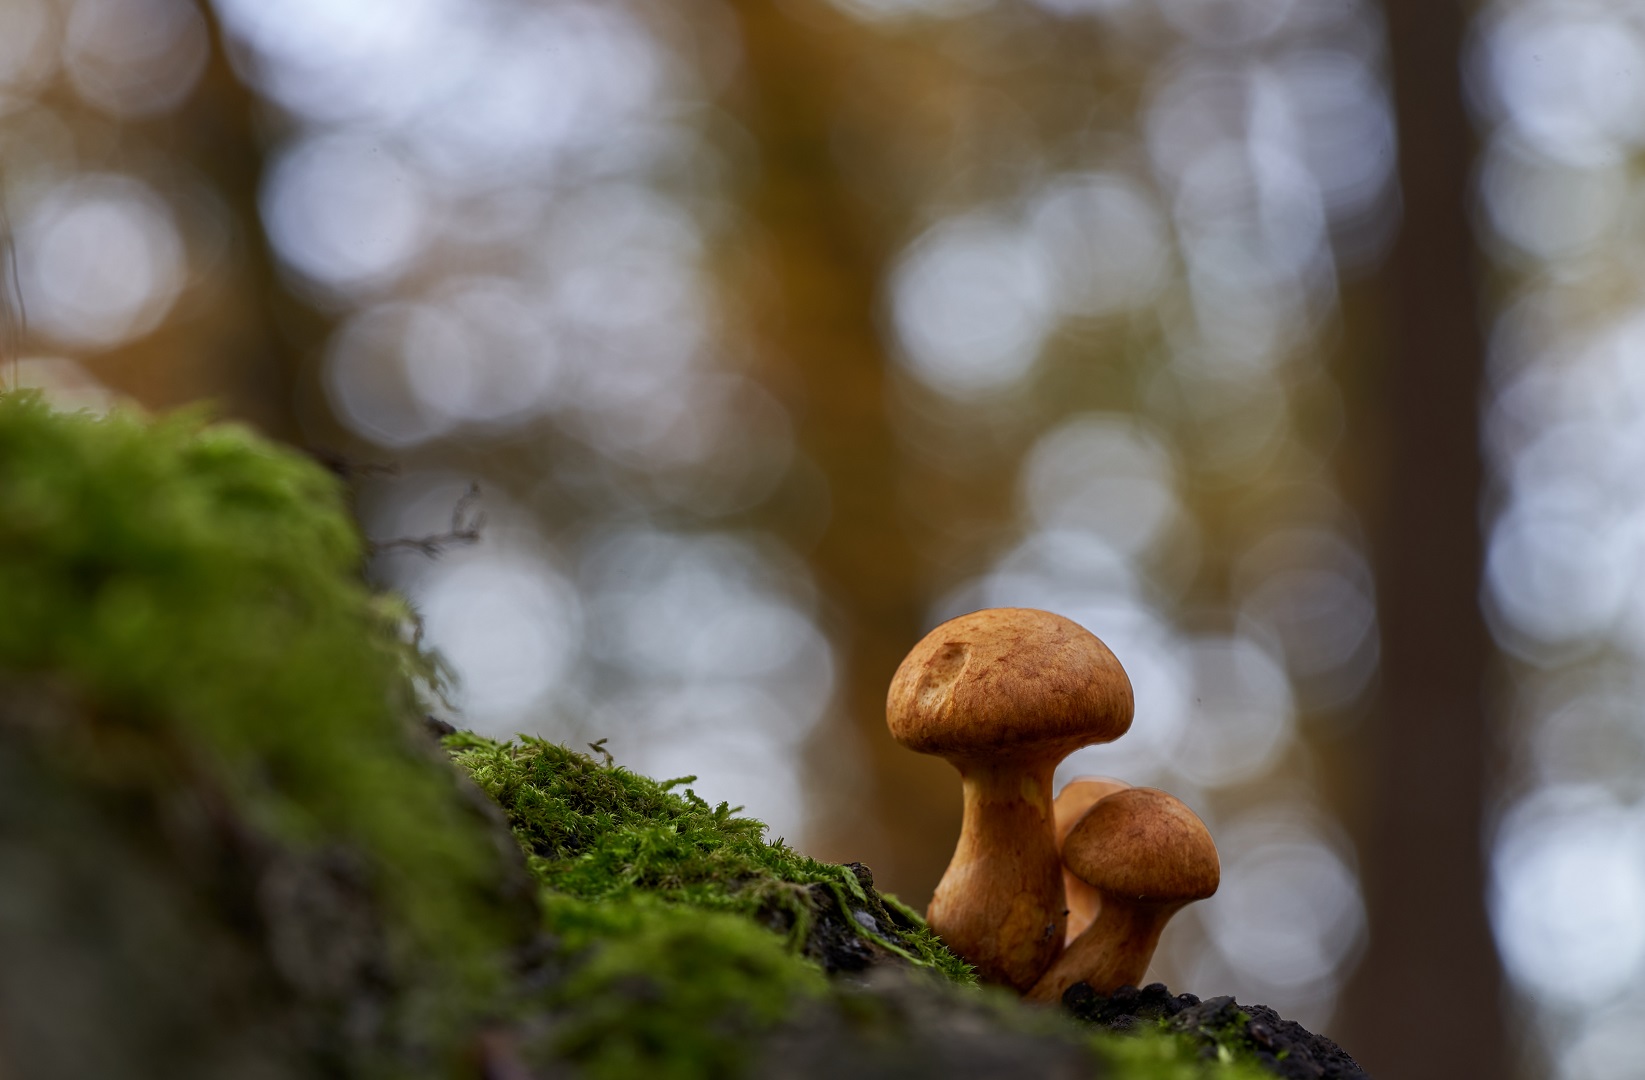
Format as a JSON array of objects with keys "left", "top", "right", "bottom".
[{"left": 446, "top": 732, "right": 1263, "bottom": 1080}]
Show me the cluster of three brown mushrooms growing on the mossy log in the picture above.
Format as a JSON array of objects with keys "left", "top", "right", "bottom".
[{"left": 885, "top": 608, "right": 1219, "bottom": 1001}]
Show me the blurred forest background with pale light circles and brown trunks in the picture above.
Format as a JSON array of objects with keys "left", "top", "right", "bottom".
[{"left": 0, "top": 0, "right": 1645, "bottom": 1080}]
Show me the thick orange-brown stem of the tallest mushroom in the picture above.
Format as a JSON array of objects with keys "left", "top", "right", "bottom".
[{"left": 926, "top": 761, "right": 1064, "bottom": 990}]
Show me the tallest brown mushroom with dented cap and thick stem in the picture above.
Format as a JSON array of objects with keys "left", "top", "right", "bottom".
[{"left": 885, "top": 608, "right": 1132, "bottom": 991}]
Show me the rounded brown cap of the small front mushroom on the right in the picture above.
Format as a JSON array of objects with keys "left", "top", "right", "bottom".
[{"left": 1063, "top": 787, "right": 1222, "bottom": 906}]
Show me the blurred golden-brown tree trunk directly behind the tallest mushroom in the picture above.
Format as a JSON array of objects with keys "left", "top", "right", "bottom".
[{"left": 734, "top": 0, "right": 959, "bottom": 904}]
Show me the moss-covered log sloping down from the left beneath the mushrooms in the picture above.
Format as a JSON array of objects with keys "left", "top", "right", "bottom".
[{"left": 0, "top": 395, "right": 1335, "bottom": 1080}]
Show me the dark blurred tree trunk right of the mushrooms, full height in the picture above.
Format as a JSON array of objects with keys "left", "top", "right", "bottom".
[{"left": 1344, "top": 0, "right": 1508, "bottom": 1080}]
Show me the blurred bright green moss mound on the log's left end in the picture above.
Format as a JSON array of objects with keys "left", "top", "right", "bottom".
[{"left": 0, "top": 393, "right": 519, "bottom": 1058}]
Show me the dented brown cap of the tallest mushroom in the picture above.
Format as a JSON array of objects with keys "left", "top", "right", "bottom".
[{"left": 885, "top": 608, "right": 1133, "bottom": 761}]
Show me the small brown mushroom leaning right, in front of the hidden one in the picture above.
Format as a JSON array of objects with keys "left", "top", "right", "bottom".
[{"left": 1026, "top": 787, "right": 1221, "bottom": 1001}]
